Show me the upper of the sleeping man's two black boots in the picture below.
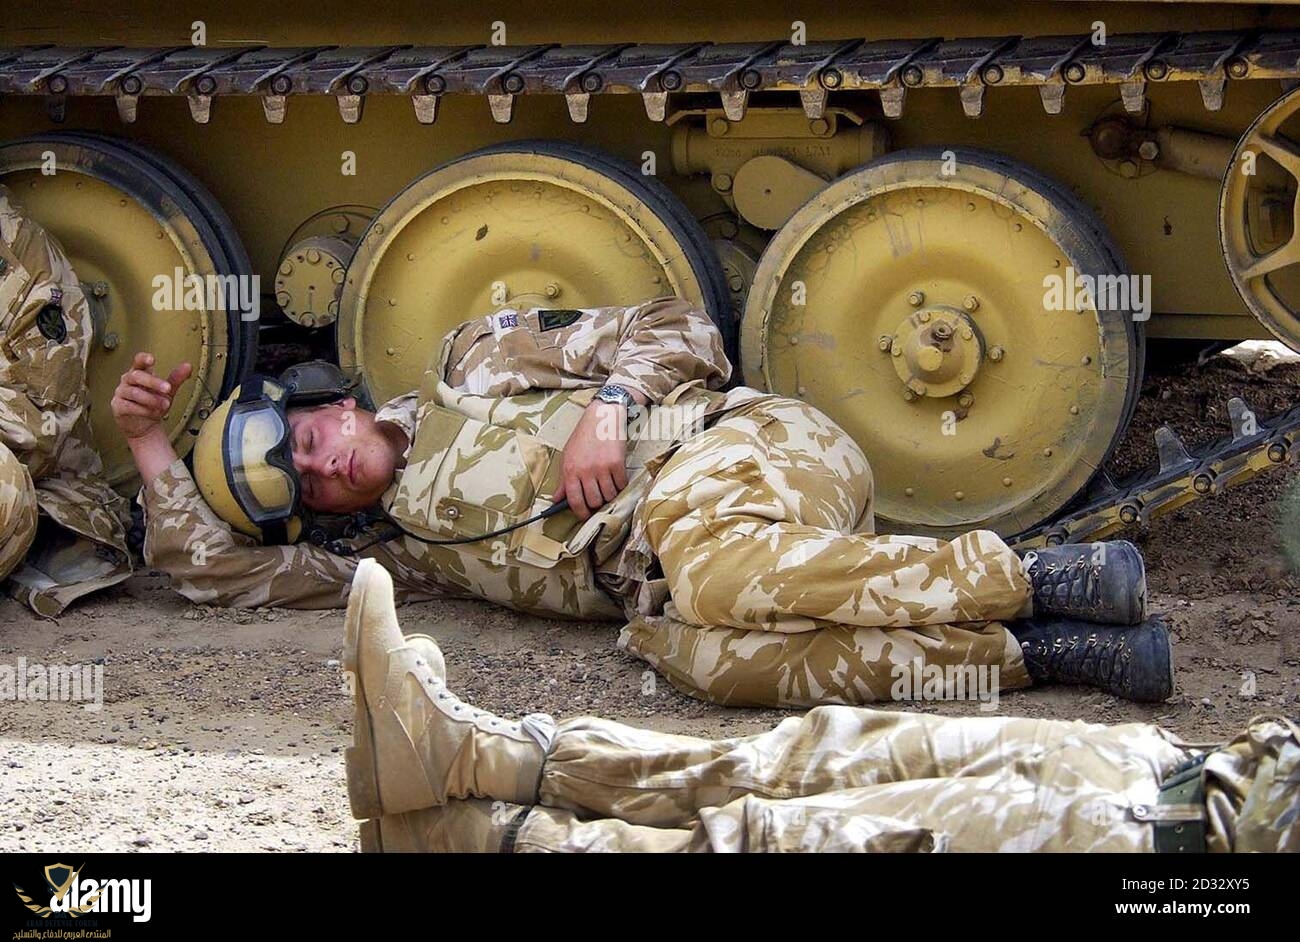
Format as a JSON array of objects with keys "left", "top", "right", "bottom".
[{"left": 1024, "top": 539, "right": 1147, "bottom": 625}]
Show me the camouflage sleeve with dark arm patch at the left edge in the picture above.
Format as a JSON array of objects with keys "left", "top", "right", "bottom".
[{"left": 0, "top": 194, "right": 91, "bottom": 479}]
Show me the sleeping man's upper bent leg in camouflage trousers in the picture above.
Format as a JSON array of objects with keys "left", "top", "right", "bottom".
[{"left": 642, "top": 400, "right": 1031, "bottom": 631}]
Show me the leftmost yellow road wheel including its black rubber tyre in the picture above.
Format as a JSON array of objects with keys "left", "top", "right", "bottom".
[{"left": 0, "top": 131, "right": 257, "bottom": 492}]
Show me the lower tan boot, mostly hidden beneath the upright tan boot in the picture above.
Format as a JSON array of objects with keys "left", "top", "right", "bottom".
[{"left": 360, "top": 798, "right": 532, "bottom": 854}]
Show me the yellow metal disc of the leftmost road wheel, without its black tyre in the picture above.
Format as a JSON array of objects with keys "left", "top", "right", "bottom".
[{"left": 0, "top": 163, "right": 229, "bottom": 492}]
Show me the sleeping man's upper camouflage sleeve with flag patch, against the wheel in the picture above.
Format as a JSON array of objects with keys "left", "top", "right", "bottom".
[{"left": 445, "top": 298, "right": 731, "bottom": 403}]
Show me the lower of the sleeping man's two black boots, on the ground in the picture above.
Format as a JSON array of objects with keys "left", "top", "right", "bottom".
[{"left": 1008, "top": 617, "right": 1174, "bottom": 703}]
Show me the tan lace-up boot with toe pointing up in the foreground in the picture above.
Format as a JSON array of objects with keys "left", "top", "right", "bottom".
[{"left": 343, "top": 560, "right": 555, "bottom": 819}]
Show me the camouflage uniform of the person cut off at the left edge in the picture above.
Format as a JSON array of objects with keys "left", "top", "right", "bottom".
[{"left": 0, "top": 186, "right": 131, "bottom": 616}]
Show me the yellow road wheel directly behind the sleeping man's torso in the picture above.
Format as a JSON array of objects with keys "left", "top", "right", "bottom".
[{"left": 337, "top": 142, "right": 736, "bottom": 403}]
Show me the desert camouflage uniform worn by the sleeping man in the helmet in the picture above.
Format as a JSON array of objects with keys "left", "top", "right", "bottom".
[{"left": 142, "top": 299, "right": 1030, "bottom": 706}]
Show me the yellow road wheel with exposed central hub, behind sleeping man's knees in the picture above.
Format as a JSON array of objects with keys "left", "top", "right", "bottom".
[{"left": 741, "top": 149, "right": 1141, "bottom": 535}]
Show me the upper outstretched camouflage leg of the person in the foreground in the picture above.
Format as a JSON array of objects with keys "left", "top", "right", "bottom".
[{"left": 540, "top": 707, "right": 1186, "bottom": 828}]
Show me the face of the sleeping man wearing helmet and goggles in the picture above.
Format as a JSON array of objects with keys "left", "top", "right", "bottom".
[{"left": 289, "top": 398, "right": 402, "bottom": 513}]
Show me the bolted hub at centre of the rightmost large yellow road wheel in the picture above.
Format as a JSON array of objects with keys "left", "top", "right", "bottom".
[{"left": 888, "top": 307, "right": 984, "bottom": 400}]
